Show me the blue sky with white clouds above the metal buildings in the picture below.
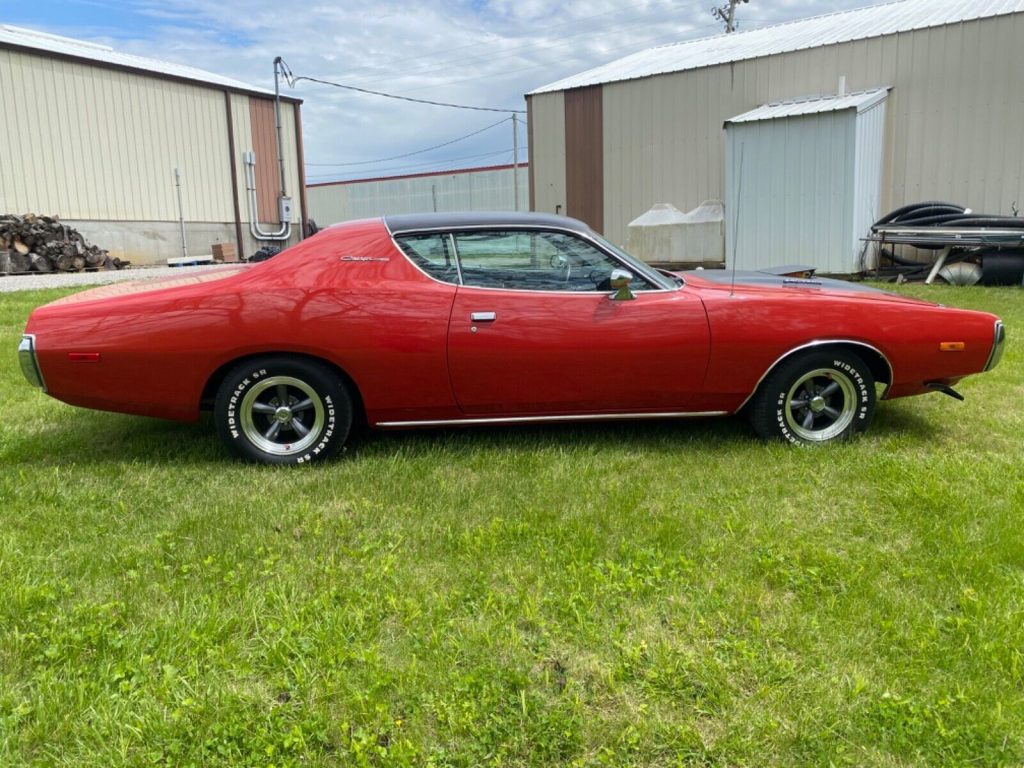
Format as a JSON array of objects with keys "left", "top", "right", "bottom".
[{"left": 0, "top": 0, "right": 872, "bottom": 182}]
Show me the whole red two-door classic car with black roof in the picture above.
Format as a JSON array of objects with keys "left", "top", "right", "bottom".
[{"left": 18, "top": 214, "right": 1005, "bottom": 464}]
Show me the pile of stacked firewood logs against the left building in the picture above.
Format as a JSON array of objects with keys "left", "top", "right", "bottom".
[{"left": 0, "top": 213, "right": 129, "bottom": 274}]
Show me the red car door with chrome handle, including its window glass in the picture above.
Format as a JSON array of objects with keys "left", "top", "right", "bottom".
[{"left": 447, "top": 230, "right": 709, "bottom": 416}]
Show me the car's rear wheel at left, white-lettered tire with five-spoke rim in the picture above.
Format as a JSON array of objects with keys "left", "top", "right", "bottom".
[{"left": 213, "top": 356, "right": 352, "bottom": 464}]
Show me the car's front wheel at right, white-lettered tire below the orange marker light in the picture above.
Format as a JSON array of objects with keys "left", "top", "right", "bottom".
[{"left": 751, "top": 350, "right": 874, "bottom": 445}]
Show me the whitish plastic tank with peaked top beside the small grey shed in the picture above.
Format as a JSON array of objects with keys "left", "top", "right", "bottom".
[{"left": 626, "top": 200, "right": 725, "bottom": 264}]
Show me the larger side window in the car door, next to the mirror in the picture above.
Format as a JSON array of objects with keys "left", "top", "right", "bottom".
[{"left": 455, "top": 230, "right": 649, "bottom": 291}]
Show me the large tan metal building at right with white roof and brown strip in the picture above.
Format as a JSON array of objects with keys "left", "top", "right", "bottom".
[{"left": 526, "top": 0, "right": 1024, "bottom": 256}]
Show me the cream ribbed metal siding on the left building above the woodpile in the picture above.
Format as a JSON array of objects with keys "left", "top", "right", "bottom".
[{"left": 0, "top": 49, "right": 234, "bottom": 221}]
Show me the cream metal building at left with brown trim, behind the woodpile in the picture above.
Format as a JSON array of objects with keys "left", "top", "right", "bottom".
[{"left": 0, "top": 26, "right": 306, "bottom": 264}]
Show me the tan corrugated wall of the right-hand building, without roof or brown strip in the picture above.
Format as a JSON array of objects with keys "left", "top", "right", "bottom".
[{"left": 528, "top": 13, "right": 1024, "bottom": 243}]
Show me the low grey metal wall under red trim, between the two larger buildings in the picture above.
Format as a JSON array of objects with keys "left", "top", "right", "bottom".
[{"left": 306, "top": 165, "right": 529, "bottom": 226}]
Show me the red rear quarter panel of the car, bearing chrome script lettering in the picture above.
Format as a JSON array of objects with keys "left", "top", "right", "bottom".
[{"left": 27, "top": 221, "right": 455, "bottom": 420}]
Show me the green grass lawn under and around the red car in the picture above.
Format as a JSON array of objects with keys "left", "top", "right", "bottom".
[{"left": 0, "top": 286, "right": 1024, "bottom": 766}]
